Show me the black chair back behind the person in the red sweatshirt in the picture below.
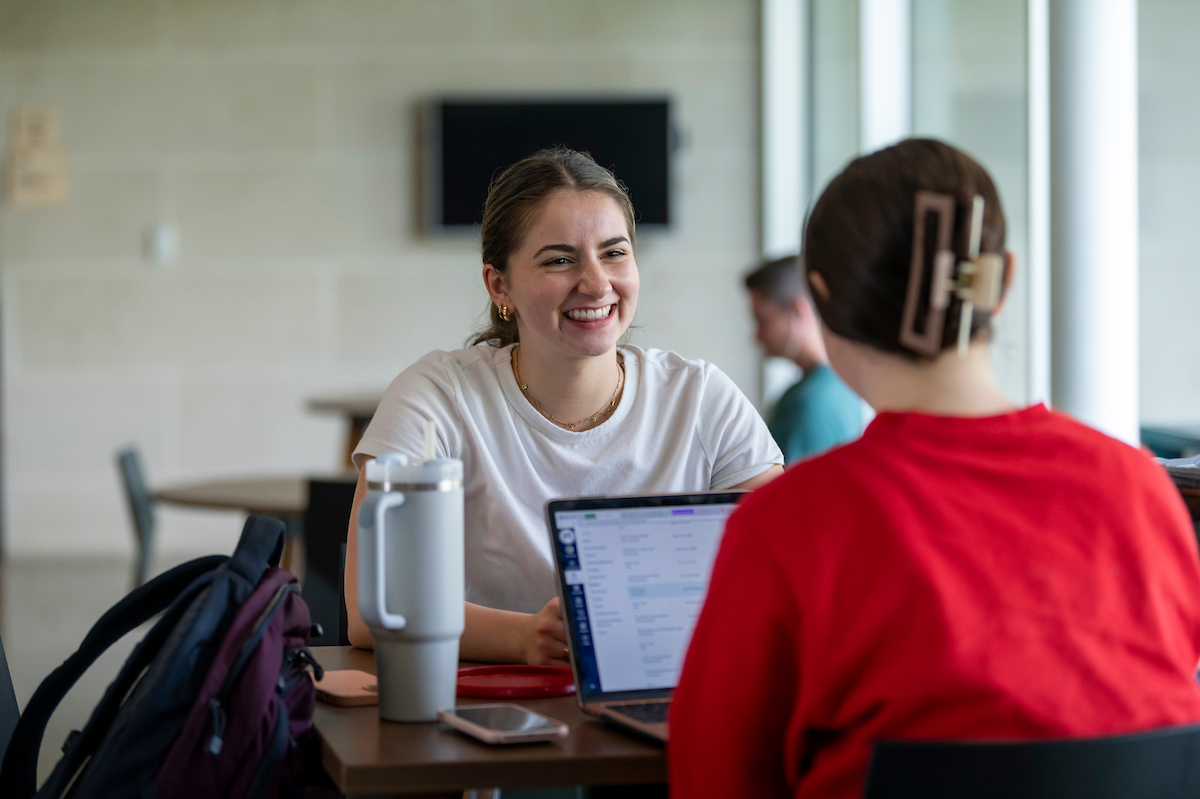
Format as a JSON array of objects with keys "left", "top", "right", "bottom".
[{"left": 863, "top": 725, "right": 1200, "bottom": 799}]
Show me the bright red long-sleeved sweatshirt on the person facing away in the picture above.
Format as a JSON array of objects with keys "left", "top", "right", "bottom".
[{"left": 668, "top": 405, "right": 1200, "bottom": 799}]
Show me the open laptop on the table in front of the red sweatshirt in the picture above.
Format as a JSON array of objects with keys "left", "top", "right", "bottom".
[{"left": 546, "top": 492, "right": 744, "bottom": 741}]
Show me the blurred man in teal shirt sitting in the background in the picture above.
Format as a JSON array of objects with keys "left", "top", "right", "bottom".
[{"left": 745, "top": 256, "right": 863, "bottom": 463}]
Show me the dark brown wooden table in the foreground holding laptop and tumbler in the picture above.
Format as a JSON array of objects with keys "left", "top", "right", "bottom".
[{"left": 312, "top": 647, "right": 667, "bottom": 794}]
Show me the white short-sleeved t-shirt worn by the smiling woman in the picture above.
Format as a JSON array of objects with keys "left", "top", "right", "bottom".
[{"left": 354, "top": 344, "right": 784, "bottom": 613}]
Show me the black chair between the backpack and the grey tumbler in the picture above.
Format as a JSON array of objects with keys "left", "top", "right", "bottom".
[{"left": 301, "top": 479, "right": 355, "bottom": 647}]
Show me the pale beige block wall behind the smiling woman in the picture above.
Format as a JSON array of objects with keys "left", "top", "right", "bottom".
[{"left": 0, "top": 0, "right": 758, "bottom": 555}]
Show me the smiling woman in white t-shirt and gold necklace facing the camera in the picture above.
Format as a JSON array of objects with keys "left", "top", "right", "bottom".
[{"left": 346, "top": 149, "right": 782, "bottom": 665}]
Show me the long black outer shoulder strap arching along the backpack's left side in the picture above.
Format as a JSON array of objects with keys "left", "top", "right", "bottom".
[{"left": 0, "top": 555, "right": 229, "bottom": 799}]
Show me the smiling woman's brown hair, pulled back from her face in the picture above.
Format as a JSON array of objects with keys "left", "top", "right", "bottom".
[{"left": 470, "top": 146, "right": 634, "bottom": 347}]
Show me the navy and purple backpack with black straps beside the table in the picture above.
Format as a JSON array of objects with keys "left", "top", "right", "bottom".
[{"left": 0, "top": 516, "right": 340, "bottom": 799}]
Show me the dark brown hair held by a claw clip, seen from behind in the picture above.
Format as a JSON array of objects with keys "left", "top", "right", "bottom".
[{"left": 803, "top": 139, "right": 1004, "bottom": 358}]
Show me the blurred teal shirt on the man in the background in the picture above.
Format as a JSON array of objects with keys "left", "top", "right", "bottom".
[{"left": 767, "top": 364, "right": 863, "bottom": 463}]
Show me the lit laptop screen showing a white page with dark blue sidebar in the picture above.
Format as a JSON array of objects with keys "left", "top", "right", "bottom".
[{"left": 554, "top": 503, "right": 736, "bottom": 693}]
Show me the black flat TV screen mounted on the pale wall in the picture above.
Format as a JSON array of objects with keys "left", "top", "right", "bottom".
[{"left": 425, "top": 98, "right": 671, "bottom": 230}]
